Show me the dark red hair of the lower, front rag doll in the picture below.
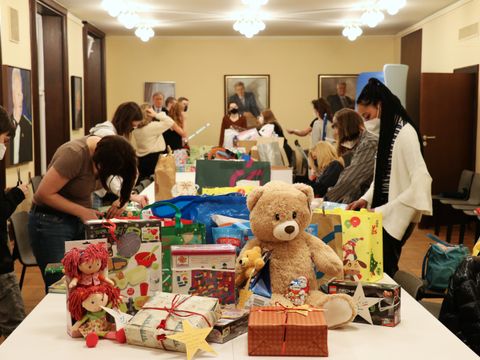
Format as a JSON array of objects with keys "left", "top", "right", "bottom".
[{"left": 68, "top": 283, "right": 121, "bottom": 320}]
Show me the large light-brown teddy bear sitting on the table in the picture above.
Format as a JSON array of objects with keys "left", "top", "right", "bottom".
[{"left": 236, "top": 181, "right": 356, "bottom": 328}]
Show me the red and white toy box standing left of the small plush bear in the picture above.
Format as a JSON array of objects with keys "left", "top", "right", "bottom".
[{"left": 171, "top": 244, "right": 236, "bottom": 305}]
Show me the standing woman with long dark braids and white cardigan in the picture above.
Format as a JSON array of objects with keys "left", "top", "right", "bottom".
[{"left": 349, "top": 78, "right": 432, "bottom": 276}]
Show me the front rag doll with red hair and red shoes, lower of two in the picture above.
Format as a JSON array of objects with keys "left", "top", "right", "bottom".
[{"left": 68, "top": 283, "right": 123, "bottom": 347}]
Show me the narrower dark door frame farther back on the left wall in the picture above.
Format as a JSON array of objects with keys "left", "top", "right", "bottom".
[{"left": 83, "top": 21, "right": 107, "bottom": 135}]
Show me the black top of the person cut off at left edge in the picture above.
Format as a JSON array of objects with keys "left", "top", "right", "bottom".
[{"left": 0, "top": 188, "right": 26, "bottom": 274}]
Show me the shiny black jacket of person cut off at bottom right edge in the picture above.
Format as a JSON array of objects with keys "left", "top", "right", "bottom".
[{"left": 439, "top": 256, "right": 480, "bottom": 356}]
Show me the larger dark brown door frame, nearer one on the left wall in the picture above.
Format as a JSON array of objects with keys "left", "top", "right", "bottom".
[{"left": 30, "top": 0, "right": 70, "bottom": 175}]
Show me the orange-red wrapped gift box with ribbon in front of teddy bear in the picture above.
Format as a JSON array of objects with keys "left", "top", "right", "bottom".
[{"left": 248, "top": 306, "right": 328, "bottom": 356}]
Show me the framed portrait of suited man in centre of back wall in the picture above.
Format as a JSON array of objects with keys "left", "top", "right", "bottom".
[{"left": 224, "top": 75, "right": 270, "bottom": 116}]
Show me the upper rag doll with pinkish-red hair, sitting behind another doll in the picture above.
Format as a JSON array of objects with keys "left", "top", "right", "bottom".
[{"left": 62, "top": 243, "right": 114, "bottom": 289}]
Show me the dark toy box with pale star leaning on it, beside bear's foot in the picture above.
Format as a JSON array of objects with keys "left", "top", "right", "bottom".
[{"left": 328, "top": 280, "right": 401, "bottom": 327}]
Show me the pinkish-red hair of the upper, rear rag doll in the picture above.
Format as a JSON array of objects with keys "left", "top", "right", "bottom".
[{"left": 62, "top": 243, "right": 108, "bottom": 279}]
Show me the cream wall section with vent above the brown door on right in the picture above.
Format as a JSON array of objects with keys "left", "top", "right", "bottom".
[{"left": 401, "top": 0, "right": 480, "bottom": 171}]
